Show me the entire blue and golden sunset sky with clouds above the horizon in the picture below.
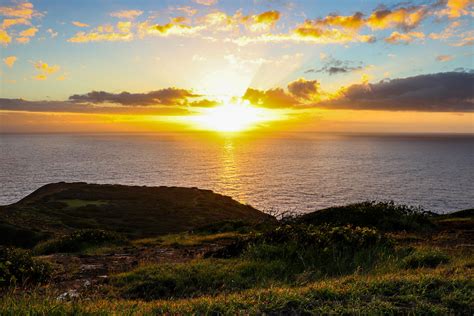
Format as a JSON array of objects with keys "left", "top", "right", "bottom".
[{"left": 0, "top": 0, "right": 474, "bottom": 133}]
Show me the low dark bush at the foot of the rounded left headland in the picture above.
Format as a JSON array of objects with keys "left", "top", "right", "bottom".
[{"left": 34, "top": 229, "right": 125, "bottom": 255}]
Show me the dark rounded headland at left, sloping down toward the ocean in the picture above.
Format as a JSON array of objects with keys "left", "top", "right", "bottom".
[{"left": 0, "top": 182, "right": 273, "bottom": 246}]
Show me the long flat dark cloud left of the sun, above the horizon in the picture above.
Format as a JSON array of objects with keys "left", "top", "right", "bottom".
[{"left": 69, "top": 88, "right": 200, "bottom": 106}]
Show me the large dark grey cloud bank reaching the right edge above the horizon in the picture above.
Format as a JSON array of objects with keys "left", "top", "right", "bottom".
[{"left": 320, "top": 72, "right": 474, "bottom": 112}]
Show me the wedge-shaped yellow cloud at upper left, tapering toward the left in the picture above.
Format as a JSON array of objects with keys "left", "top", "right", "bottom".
[{"left": 67, "top": 21, "right": 133, "bottom": 43}]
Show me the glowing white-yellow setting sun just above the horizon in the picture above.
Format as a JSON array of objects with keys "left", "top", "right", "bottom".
[{"left": 190, "top": 101, "right": 275, "bottom": 132}]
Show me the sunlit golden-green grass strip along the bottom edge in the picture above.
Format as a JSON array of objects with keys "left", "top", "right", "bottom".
[{"left": 0, "top": 263, "right": 474, "bottom": 315}]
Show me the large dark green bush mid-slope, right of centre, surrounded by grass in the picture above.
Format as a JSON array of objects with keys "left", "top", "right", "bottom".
[{"left": 207, "top": 224, "right": 392, "bottom": 274}]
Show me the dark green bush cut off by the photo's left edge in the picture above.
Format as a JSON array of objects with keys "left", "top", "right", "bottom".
[{"left": 0, "top": 247, "right": 52, "bottom": 286}]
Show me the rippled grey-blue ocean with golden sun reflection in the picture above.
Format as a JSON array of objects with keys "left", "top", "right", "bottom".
[{"left": 0, "top": 133, "right": 474, "bottom": 213}]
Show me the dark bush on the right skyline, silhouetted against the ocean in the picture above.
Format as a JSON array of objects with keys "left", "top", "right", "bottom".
[{"left": 296, "top": 201, "right": 434, "bottom": 231}]
